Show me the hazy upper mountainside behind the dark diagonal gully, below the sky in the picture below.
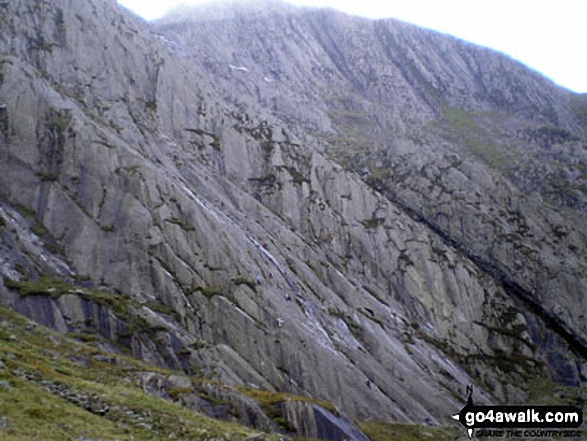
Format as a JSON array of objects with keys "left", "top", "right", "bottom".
[{"left": 154, "top": 0, "right": 585, "bottom": 382}]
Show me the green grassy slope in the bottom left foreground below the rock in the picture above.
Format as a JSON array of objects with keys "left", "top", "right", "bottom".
[{"left": 0, "top": 306, "right": 264, "bottom": 440}]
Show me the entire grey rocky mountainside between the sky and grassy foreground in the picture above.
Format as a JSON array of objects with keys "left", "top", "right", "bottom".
[{"left": 0, "top": 0, "right": 587, "bottom": 430}]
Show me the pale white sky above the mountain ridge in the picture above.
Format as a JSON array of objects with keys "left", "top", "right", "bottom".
[{"left": 118, "top": 0, "right": 587, "bottom": 93}]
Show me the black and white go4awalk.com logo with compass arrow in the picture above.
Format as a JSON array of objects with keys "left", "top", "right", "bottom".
[{"left": 453, "top": 386, "right": 583, "bottom": 438}]
